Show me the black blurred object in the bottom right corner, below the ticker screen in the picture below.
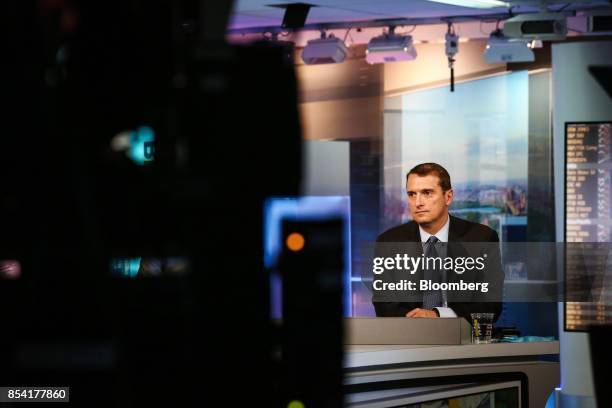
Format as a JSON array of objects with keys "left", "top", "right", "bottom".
[{"left": 589, "top": 326, "right": 612, "bottom": 407}]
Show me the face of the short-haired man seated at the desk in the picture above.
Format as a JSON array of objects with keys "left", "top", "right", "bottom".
[{"left": 406, "top": 174, "right": 453, "bottom": 225}]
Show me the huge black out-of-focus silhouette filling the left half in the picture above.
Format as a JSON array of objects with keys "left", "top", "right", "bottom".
[{"left": 0, "top": 0, "right": 310, "bottom": 406}]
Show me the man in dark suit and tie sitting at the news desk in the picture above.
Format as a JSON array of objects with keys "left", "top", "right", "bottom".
[{"left": 372, "top": 163, "right": 503, "bottom": 321}]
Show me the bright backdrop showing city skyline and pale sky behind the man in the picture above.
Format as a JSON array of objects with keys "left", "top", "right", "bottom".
[{"left": 383, "top": 71, "right": 529, "bottom": 239}]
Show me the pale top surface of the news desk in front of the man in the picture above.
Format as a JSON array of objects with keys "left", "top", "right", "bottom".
[{"left": 344, "top": 341, "right": 559, "bottom": 368}]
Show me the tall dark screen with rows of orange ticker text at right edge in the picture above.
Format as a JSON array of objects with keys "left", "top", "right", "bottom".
[{"left": 564, "top": 121, "right": 612, "bottom": 331}]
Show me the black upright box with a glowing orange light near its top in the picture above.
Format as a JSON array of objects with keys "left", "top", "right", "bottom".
[{"left": 279, "top": 219, "right": 344, "bottom": 408}]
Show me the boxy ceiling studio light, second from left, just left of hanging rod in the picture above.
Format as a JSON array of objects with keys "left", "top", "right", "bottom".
[{"left": 366, "top": 27, "right": 417, "bottom": 64}]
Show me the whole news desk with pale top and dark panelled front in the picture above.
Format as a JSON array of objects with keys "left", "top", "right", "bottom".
[{"left": 344, "top": 322, "right": 560, "bottom": 408}]
